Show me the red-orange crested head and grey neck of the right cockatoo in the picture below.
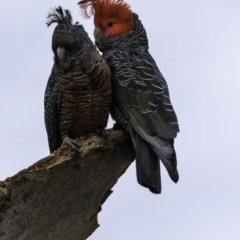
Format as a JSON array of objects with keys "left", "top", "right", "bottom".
[{"left": 78, "top": 0, "right": 148, "bottom": 52}]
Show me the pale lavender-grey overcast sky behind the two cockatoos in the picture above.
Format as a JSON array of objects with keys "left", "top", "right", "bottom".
[{"left": 0, "top": 0, "right": 240, "bottom": 240}]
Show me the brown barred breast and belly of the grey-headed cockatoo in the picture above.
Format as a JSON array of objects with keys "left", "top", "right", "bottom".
[{"left": 59, "top": 52, "right": 111, "bottom": 141}]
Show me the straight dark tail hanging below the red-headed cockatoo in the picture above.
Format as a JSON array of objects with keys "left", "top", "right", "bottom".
[{"left": 136, "top": 134, "right": 161, "bottom": 194}]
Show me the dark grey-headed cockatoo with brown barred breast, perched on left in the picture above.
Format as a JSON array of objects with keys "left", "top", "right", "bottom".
[{"left": 44, "top": 7, "right": 112, "bottom": 152}]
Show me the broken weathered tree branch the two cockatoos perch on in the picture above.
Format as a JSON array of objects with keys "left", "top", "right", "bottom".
[{"left": 0, "top": 130, "right": 135, "bottom": 240}]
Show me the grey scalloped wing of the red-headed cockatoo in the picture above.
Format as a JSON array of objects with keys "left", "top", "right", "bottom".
[{"left": 109, "top": 51, "right": 179, "bottom": 139}]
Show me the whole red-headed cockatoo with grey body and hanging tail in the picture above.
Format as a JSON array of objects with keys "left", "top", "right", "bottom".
[{"left": 78, "top": 0, "right": 179, "bottom": 193}]
